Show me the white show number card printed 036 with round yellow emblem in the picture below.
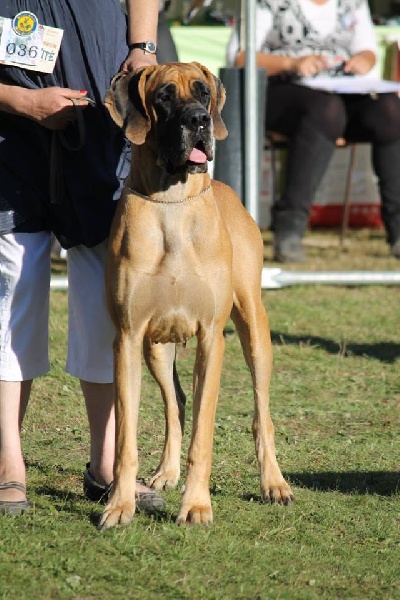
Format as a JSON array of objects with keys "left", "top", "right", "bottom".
[{"left": 0, "top": 11, "right": 64, "bottom": 73}]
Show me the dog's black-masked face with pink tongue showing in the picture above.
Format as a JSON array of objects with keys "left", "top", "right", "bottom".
[{"left": 152, "top": 80, "right": 214, "bottom": 173}]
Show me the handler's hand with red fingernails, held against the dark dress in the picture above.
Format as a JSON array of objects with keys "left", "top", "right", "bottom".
[{"left": 18, "top": 87, "right": 89, "bottom": 131}]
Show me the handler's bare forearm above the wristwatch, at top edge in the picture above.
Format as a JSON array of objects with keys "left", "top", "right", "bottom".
[{"left": 126, "top": 0, "right": 159, "bottom": 44}]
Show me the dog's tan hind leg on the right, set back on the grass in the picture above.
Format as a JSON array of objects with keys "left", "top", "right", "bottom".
[{"left": 231, "top": 296, "right": 293, "bottom": 504}]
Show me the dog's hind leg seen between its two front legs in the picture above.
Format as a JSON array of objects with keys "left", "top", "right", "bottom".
[{"left": 143, "top": 339, "right": 186, "bottom": 490}]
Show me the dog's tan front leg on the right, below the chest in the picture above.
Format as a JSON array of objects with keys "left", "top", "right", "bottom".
[{"left": 177, "top": 329, "right": 225, "bottom": 524}]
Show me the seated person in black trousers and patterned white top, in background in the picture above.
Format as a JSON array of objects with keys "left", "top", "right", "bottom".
[{"left": 228, "top": 0, "right": 400, "bottom": 262}]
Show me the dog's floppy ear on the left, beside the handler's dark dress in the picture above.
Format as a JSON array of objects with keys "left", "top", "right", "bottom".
[{"left": 104, "top": 67, "right": 154, "bottom": 145}]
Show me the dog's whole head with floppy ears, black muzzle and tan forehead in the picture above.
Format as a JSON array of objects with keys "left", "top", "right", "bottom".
[{"left": 105, "top": 62, "right": 228, "bottom": 173}]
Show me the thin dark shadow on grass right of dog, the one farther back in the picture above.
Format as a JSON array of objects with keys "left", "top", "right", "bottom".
[{"left": 271, "top": 331, "right": 400, "bottom": 363}]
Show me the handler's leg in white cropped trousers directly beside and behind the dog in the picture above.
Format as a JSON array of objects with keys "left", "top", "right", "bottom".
[{"left": 67, "top": 242, "right": 165, "bottom": 510}]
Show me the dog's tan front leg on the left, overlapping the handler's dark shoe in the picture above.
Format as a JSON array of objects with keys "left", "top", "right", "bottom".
[{"left": 99, "top": 331, "right": 142, "bottom": 529}]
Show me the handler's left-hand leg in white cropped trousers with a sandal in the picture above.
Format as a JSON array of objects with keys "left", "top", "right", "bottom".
[{"left": 0, "top": 232, "right": 50, "bottom": 514}]
